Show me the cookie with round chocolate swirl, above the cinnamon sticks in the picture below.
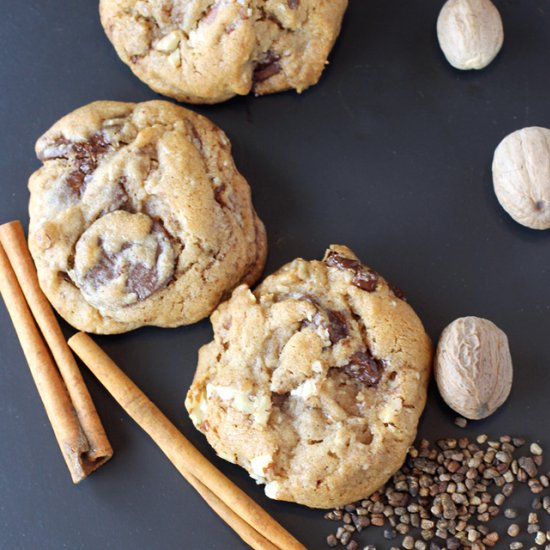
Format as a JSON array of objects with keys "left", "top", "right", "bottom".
[{"left": 29, "top": 101, "right": 267, "bottom": 334}]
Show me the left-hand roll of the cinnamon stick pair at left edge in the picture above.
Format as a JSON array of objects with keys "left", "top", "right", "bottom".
[{"left": 0, "top": 245, "right": 101, "bottom": 483}]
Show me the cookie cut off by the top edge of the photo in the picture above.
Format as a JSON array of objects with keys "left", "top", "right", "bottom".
[{"left": 99, "top": 0, "right": 347, "bottom": 103}]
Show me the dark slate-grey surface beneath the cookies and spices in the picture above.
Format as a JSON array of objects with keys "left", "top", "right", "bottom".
[{"left": 0, "top": 0, "right": 550, "bottom": 550}]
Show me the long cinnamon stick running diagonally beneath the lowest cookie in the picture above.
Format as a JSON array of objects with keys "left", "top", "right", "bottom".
[{"left": 69, "top": 332, "right": 305, "bottom": 550}]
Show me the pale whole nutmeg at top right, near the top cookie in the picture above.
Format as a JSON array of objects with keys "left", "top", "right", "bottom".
[{"left": 437, "top": 0, "right": 504, "bottom": 70}]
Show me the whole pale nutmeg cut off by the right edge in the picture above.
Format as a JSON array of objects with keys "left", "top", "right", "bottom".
[{"left": 493, "top": 126, "right": 550, "bottom": 229}]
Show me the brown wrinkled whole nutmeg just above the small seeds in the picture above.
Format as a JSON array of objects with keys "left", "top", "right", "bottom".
[{"left": 435, "top": 317, "right": 513, "bottom": 420}]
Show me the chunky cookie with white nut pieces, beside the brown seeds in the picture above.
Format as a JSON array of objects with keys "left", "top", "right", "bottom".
[{"left": 185, "top": 245, "right": 432, "bottom": 508}]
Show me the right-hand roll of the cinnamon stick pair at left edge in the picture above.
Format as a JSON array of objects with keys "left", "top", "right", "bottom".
[{"left": 0, "top": 221, "right": 113, "bottom": 477}]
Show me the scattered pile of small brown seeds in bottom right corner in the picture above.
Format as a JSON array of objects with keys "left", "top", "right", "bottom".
[{"left": 325, "top": 435, "right": 550, "bottom": 550}]
